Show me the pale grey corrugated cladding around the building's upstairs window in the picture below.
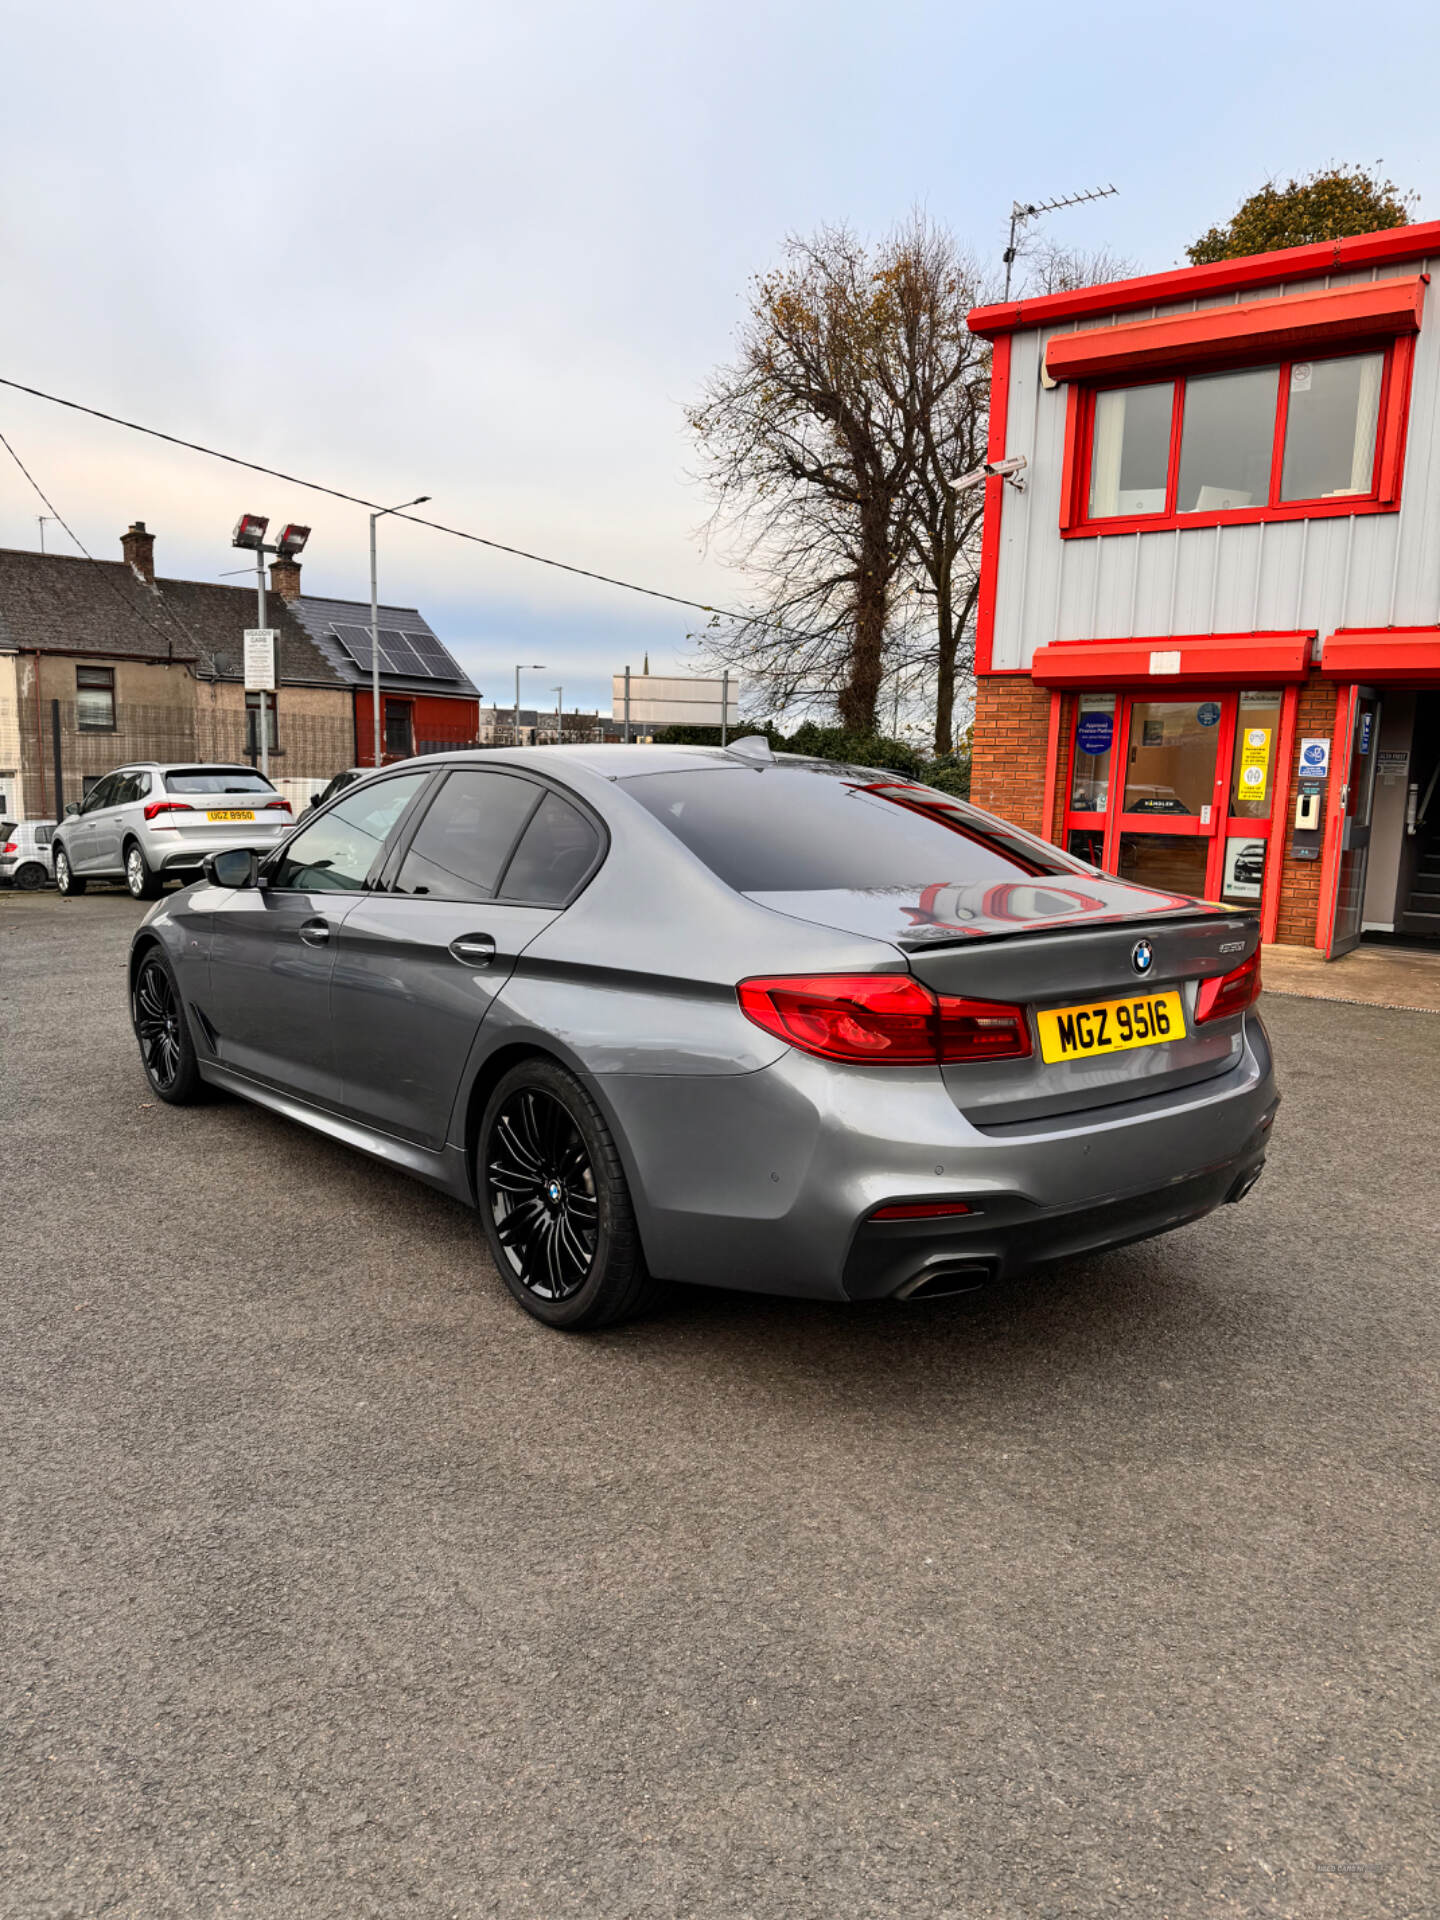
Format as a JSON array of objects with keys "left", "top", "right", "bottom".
[{"left": 993, "top": 261, "right": 1440, "bottom": 668}]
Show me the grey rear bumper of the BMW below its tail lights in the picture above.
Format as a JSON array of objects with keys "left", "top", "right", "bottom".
[{"left": 593, "top": 1014, "right": 1279, "bottom": 1300}]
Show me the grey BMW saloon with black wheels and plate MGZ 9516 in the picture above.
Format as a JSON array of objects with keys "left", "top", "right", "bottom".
[{"left": 131, "top": 741, "right": 1277, "bottom": 1329}]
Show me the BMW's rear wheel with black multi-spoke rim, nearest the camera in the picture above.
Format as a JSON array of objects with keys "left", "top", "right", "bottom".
[{"left": 474, "top": 1056, "right": 664, "bottom": 1332}]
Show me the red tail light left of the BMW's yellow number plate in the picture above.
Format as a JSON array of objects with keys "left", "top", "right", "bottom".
[{"left": 735, "top": 973, "right": 1029, "bottom": 1068}]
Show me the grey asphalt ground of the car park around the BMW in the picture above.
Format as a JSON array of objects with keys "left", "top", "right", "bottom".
[{"left": 0, "top": 893, "right": 1440, "bottom": 1920}]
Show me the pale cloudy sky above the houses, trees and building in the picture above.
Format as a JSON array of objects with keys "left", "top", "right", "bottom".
[{"left": 0, "top": 0, "right": 1440, "bottom": 705}]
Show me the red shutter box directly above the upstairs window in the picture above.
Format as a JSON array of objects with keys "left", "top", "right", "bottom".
[{"left": 1044, "top": 275, "right": 1427, "bottom": 380}]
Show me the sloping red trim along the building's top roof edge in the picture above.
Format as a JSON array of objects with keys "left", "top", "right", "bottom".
[{"left": 970, "top": 221, "right": 1440, "bottom": 338}]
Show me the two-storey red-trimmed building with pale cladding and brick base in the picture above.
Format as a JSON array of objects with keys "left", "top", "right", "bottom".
[{"left": 970, "top": 223, "right": 1440, "bottom": 958}]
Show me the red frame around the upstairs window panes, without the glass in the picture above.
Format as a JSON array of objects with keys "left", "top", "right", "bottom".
[{"left": 1060, "top": 334, "right": 1415, "bottom": 540}]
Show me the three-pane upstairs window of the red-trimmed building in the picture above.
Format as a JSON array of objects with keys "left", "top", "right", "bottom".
[{"left": 1075, "top": 349, "right": 1398, "bottom": 530}]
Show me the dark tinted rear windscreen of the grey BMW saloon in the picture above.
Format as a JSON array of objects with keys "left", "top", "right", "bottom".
[{"left": 624, "top": 762, "right": 1085, "bottom": 893}]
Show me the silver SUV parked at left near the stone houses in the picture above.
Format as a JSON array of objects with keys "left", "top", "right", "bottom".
[{"left": 52, "top": 760, "right": 296, "bottom": 900}]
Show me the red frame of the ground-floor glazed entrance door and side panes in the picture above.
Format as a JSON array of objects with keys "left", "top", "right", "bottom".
[{"left": 1060, "top": 684, "right": 1300, "bottom": 941}]
